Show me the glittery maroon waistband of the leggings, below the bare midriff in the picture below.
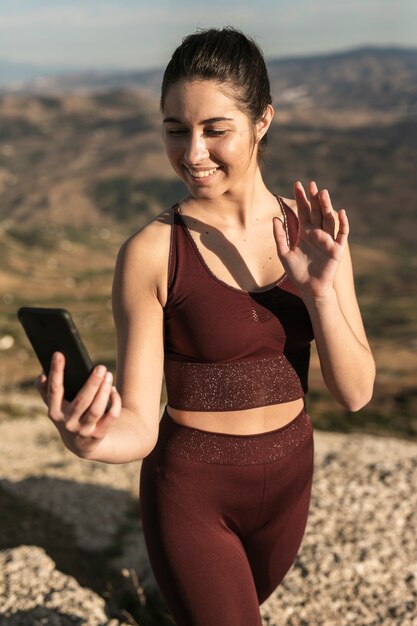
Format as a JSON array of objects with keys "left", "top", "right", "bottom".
[{"left": 160, "top": 409, "right": 313, "bottom": 465}]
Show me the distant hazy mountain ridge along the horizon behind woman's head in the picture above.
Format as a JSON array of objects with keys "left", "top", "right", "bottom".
[{"left": 0, "top": 47, "right": 417, "bottom": 111}]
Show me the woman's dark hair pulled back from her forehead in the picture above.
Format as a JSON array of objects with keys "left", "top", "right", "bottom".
[{"left": 160, "top": 26, "right": 272, "bottom": 153}]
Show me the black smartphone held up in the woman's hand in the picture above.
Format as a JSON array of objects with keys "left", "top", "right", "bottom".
[{"left": 17, "top": 307, "right": 94, "bottom": 401}]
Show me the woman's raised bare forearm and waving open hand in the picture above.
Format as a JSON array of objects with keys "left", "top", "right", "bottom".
[{"left": 274, "top": 183, "right": 375, "bottom": 411}]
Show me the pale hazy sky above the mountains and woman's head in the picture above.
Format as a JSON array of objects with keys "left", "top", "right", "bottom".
[{"left": 0, "top": 0, "right": 417, "bottom": 68}]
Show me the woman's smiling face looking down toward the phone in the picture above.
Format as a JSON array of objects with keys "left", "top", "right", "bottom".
[{"left": 164, "top": 80, "right": 264, "bottom": 199}]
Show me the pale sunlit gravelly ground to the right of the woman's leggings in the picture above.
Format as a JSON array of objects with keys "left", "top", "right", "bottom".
[{"left": 262, "top": 432, "right": 417, "bottom": 626}]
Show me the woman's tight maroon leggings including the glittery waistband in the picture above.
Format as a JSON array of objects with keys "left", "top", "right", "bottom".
[{"left": 140, "top": 411, "right": 313, "bottom": 626}]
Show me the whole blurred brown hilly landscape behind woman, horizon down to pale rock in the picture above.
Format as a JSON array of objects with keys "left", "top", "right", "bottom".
[{"left": 0, "top": 48, "right": 417, "bottom": 436}]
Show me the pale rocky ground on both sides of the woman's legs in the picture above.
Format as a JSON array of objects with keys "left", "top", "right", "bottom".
[{"left": 0, "top": 392, "right": 417, "bottom": 626}]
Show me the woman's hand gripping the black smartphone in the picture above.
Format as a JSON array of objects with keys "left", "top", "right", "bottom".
[{"left": 36, "top": 352, "right": 122, "bottom": 458}]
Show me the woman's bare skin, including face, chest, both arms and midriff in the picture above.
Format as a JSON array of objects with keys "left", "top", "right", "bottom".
[{"left": 38, "top": 81, "right": 375, "bottom": 463}]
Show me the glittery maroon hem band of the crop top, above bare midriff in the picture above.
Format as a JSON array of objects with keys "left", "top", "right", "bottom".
[{"left": 165, "top": 355, "right": 304, "bottom": 411}]
